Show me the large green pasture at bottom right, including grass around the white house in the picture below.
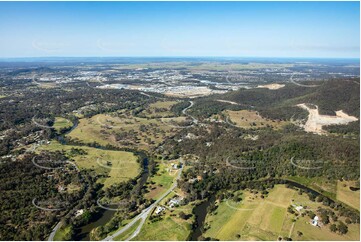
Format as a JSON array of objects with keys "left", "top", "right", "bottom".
[{"left": 204, "top": 185, "right": 360, "bottom": 240}]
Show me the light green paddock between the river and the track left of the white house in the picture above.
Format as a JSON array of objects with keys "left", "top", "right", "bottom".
[{"left": 205, "top": 186, "right": 295, "bottom": 240}]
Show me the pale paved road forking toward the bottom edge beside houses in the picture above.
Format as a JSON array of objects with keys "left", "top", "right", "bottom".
[{"left": 103, "top": 159, "right": 184, "bottom": 241}]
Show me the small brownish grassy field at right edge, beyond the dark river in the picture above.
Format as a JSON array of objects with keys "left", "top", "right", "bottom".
[{"left": 337, "top": 181, "right": 360, "bottom": 211}]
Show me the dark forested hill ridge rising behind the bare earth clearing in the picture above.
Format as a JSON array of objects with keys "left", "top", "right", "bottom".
[{"left": 225, "top": 79, "right": 360, "bottom": 117}]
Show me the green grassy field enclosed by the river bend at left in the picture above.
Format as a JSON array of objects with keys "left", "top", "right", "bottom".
[{"left": 38, "top": 141, "right": 140, "bottom": 187}]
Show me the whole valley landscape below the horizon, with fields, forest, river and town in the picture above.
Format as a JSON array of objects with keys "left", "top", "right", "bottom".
[{"left": 0, "top": 57, "right": 360, "bottom": 241}]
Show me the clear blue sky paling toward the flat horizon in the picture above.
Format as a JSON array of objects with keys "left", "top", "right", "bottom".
[{"left": 0, "top": 2, "right": 360, "bottom": 58}]
